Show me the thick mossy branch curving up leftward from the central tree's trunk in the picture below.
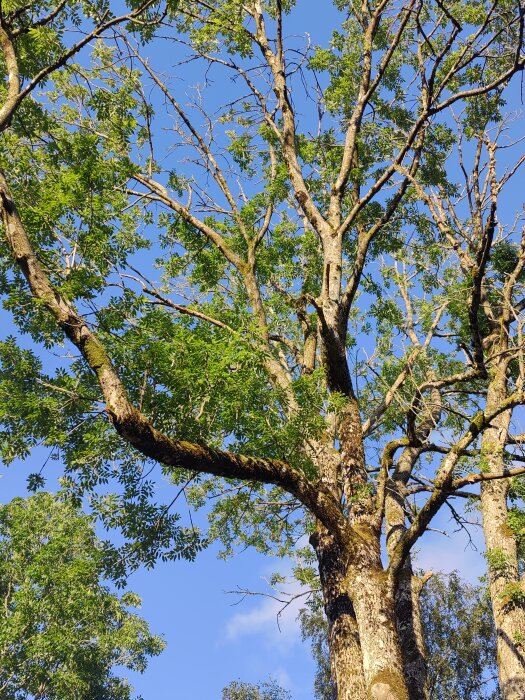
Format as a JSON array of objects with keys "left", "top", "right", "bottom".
[{"left": 0, "top": 172, "right": 351, "bottom": 547}]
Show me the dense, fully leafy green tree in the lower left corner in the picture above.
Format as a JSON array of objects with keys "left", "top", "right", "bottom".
[{"left": 0, "top": 492, "right": 164, "bottom": 700}]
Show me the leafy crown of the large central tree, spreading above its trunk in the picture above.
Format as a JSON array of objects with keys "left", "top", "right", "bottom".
[{"left": 1, "top": 1, "right": 524, "bottom": 572}]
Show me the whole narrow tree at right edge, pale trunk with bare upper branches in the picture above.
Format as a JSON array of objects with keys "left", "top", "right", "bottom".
[{"left": 396, "top": 109, "right": 525, "bottom": 697}]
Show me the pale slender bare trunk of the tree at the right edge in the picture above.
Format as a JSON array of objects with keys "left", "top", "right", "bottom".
[{"left": 480, "top": 370, "right": 525, "bottom": 700}]
